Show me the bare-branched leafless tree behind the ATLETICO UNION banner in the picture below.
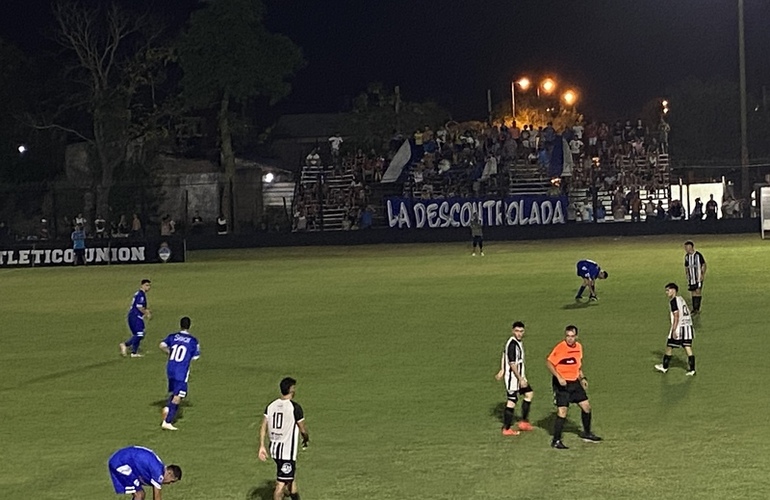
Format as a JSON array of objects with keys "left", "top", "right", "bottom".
[{"left": 34, "top": 0, "right": 171, "bottom": 219}]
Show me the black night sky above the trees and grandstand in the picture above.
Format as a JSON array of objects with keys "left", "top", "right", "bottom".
[{"left": 0, "top": 0, "right": 770, "bottom": 119}]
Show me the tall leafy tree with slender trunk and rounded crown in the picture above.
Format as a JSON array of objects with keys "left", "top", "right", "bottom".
[{"left": 178, "top": 0, "right": 304, "bottom": 230}]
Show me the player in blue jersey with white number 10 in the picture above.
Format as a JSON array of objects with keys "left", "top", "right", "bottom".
[{"left": 159, "top": 316, "right": 201, "bottom": 431}]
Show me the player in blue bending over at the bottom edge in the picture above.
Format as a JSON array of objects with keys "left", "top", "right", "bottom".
[{"left": 107, "top": 446, "right": 182, "bottom": 500}]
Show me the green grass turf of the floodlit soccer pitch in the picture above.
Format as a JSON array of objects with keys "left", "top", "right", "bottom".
[{"left": 0, "top": 235, "right": 770, "bottom": 500}]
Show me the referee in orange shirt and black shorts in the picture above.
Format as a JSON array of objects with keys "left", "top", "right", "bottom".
[{"left": 546, "top": 325, "right": 602, "bottom": 450}]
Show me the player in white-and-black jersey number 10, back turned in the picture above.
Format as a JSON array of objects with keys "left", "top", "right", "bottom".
[{"left": 259, "top": 377, "right": 310, "bottom": 500}]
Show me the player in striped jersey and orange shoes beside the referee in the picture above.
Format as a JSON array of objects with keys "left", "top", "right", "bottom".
[{"left": 495, "top": 321, "right": 535, "bottom": 436}]
